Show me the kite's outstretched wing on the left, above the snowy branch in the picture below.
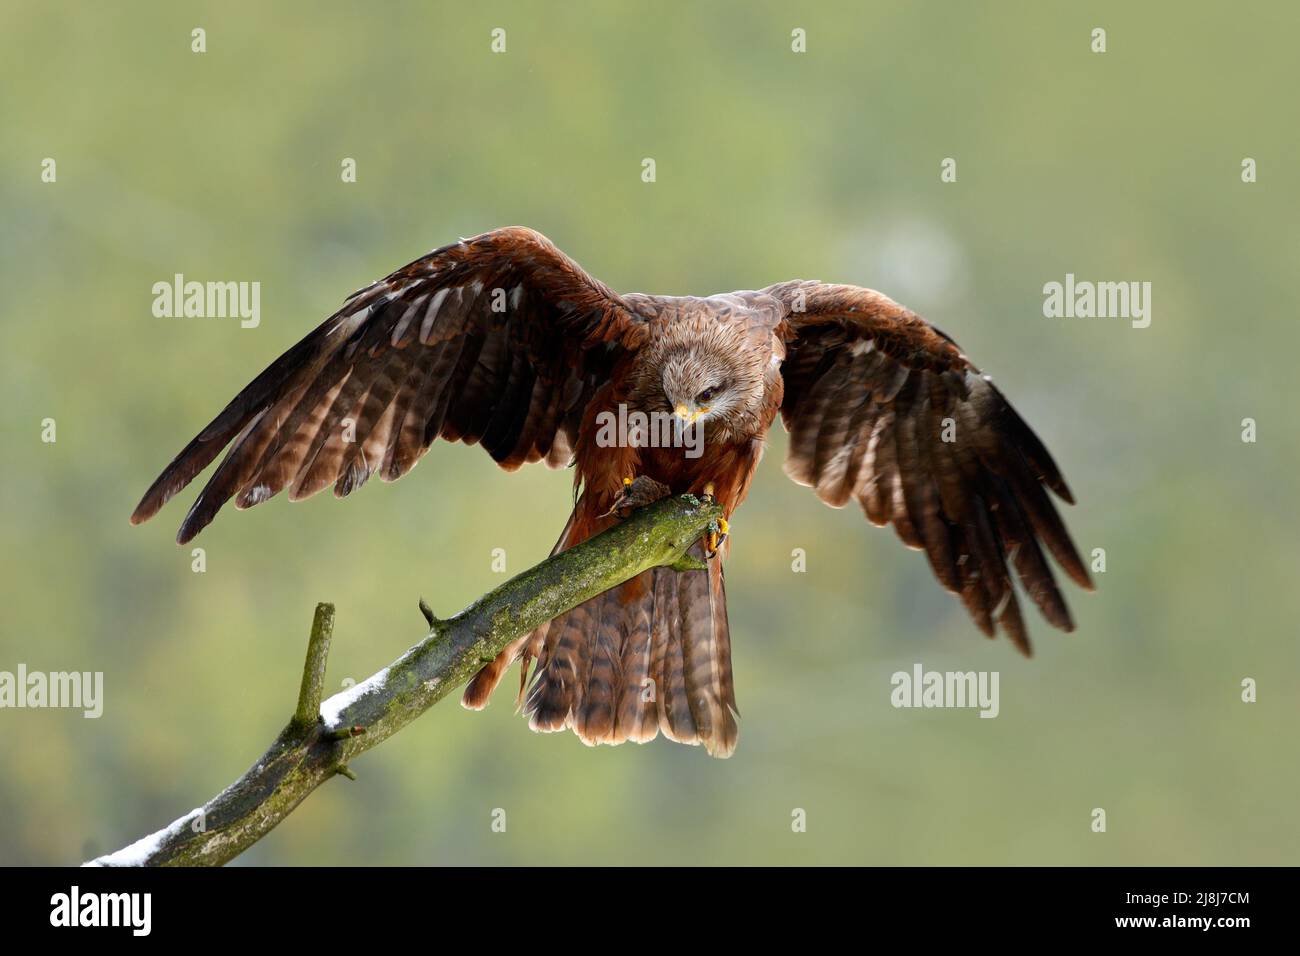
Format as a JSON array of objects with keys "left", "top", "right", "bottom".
[{"left": 131, "top": 228, "right": 645, "bottom": 544}]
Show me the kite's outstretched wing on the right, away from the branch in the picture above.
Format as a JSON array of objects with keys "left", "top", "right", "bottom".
[{"left": 764, "top": 281, "right": 1092, "bottom": 654}]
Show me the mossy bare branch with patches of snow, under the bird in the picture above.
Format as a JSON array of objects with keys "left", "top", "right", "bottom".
[{"left": 87, "top": 496, "right": 722, "bottom": 866}]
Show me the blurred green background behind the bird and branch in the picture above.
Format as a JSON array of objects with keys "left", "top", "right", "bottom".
[{"left": 0, "top": 1, "right": 1300, "bottom": 864}]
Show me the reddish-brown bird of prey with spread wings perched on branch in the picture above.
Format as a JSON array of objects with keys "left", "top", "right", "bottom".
[{"left": 131, "top": 226, "right": 1092, "bottom": 757}]
